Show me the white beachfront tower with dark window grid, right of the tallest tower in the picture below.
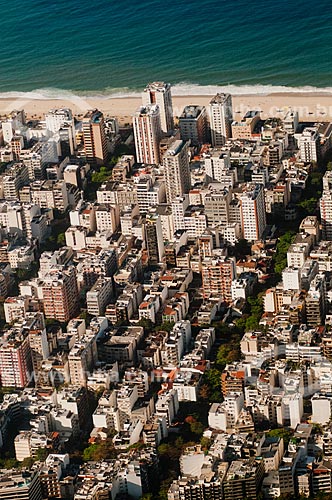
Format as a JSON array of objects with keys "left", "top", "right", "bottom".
[{"left": 209, "top": 94, "right": 233, "bottom": 147}]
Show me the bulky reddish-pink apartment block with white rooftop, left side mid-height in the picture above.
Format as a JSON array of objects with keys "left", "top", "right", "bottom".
[{"left": 42, "top": 267, "right": 78, "bottom": 322}]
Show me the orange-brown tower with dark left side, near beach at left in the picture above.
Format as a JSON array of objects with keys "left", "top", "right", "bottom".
[{"left": 83, "top": 109, "right": 108, "bottom": 165}]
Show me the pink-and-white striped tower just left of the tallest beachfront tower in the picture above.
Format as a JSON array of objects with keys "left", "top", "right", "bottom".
[{"left": 133, "top": 105, "right": 161, "bottom": 165}]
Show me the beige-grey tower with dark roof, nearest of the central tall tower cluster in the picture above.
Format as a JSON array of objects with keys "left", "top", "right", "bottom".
[{"left": 163, "top": 140, "right": 191, "bottom": 203}]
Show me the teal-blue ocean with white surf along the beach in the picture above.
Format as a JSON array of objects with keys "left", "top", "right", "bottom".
[{"left": 0, "top": 0, "right": 332, "bottom": 98}]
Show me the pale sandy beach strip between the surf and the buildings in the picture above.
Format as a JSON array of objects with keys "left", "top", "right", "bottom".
[{"left": 0, "top": 93, "right": 332, "bottom": 124}]
